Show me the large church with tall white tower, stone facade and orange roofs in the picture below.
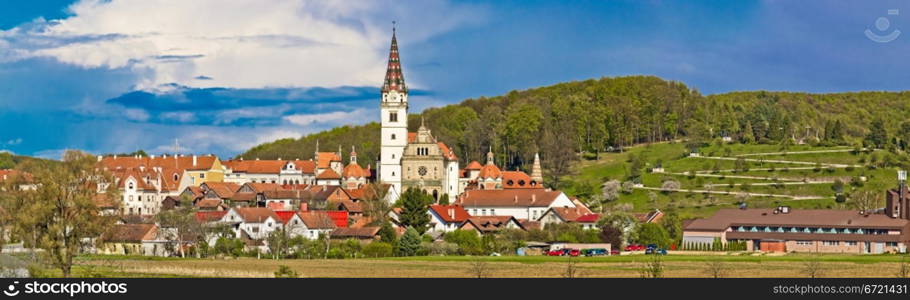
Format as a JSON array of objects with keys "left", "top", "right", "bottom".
[{"left": 377, "top": 28, "right": 543, "bottom": 203}]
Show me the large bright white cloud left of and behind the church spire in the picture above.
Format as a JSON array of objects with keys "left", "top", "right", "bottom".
[{"left": 0, "top": 0, "right": 483, "bottom": 89}]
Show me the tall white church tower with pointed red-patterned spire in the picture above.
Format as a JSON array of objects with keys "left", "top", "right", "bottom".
[{"left": 379, "top": 26, "right": 408, "bottom": 200}]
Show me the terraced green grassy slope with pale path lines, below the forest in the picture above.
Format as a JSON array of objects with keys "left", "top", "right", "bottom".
[{"left": 562, "top": 143, "right": 896, "bottom": 218}]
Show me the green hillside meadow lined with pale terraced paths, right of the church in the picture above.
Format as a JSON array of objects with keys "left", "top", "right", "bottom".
[{"left": 565, "top": 143, "right": 896, "bottom": 217}]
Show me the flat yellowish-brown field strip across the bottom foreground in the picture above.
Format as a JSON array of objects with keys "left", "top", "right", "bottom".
[{"left": 81, "top": 256, "right": 901, "bottom": 278}]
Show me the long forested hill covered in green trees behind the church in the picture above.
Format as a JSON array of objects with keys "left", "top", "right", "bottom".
[{"left": 240, "top": 76, "right": 910, "bottom": 185}]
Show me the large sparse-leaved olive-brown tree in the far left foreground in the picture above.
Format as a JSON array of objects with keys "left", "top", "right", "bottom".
[{"left": 7, "top": 151, "right": 119, "bottom": 277}]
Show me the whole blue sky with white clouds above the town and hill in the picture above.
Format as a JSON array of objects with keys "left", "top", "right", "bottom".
[{"left": 0, "top": 0, "right": 910, "bottom": 159}]
